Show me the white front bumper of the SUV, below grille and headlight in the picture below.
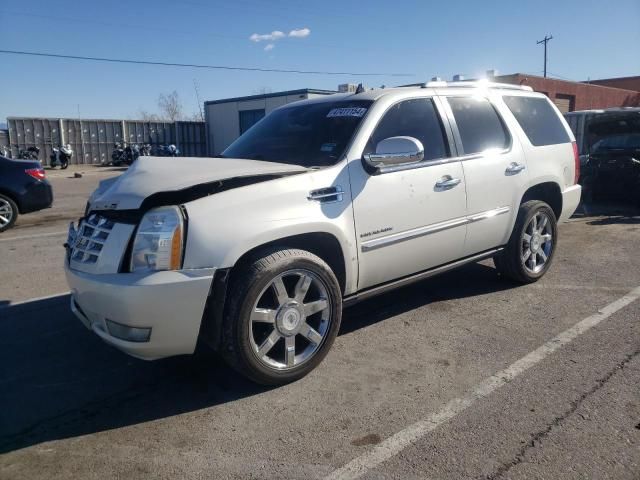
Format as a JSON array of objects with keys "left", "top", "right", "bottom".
[{"left": 65, "top": 265, "right": 214, "bottom": 360}]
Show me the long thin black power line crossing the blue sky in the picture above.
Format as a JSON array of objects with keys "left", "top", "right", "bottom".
[{"left": 0, "top": 50, "right": 415, "bottom": 77}]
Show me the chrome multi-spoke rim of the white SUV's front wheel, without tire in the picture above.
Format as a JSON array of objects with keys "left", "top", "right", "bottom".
[{"left": 249, "top": 269, "right": 333, "bottom": 370}]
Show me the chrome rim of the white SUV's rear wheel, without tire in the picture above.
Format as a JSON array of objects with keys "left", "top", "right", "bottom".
[{"left": 521, "top": 211, "right": 554, "bottom": 273}]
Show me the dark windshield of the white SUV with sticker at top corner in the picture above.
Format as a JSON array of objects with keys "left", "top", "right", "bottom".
[{"left": 221, "top": 100, "right": 373, "bottom": 167}]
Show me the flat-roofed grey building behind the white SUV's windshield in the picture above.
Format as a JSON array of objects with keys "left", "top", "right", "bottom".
[{"left": 204, "top": 88, "right": 337, "bottom": 155}]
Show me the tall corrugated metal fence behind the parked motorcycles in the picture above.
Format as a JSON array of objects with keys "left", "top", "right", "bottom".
[{"left": 7, "top": 117, "right": 206, "bottom": 164}]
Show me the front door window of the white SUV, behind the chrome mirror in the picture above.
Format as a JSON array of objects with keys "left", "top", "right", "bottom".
[{"left": 365, "top": 98, "right": 449, "bottom": 160}]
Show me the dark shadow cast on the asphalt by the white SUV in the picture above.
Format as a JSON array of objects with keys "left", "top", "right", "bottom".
[{"left": 0, "top": 264, "right": 514, "bottom": 453}]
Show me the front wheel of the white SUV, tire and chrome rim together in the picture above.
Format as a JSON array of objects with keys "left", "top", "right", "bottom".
[{"left": 221, "top": 249, "right": 342, "bottom": 385}]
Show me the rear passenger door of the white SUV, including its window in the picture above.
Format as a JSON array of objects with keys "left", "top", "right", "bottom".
[{"left": 444, "top": 92, "right": 528, "bottom": 255}]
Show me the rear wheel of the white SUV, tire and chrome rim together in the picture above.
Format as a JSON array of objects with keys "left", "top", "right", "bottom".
[{"left": 494, "top": 200, "right": 558, "bottom": 283}]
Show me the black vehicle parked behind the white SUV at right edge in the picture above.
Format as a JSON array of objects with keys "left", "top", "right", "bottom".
[{"left": 565, "top": 108, "right": 640, "bottom": 205}]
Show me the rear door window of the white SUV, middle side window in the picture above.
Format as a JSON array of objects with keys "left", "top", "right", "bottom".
[{"left": 447, "top": 97, "right": 510, "bottom": 155}]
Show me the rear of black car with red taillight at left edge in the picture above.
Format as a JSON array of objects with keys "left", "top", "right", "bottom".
[{"left": 0, "top": 156, "right": 53, "bottom": 232}]
